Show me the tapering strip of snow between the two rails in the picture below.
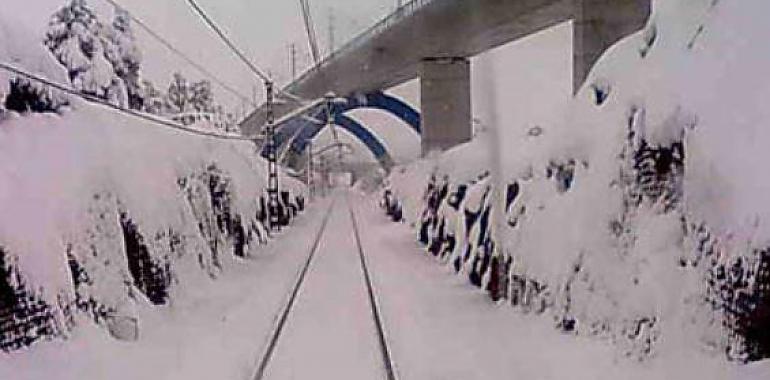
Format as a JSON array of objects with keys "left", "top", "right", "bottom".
[{"left": 264, "top": 193, "right": 384, "bottom": 379}]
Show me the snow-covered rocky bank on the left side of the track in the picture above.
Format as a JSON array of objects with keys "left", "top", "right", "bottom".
[{"left": 0, "top": 1, "right": 304, "bottom": 351}]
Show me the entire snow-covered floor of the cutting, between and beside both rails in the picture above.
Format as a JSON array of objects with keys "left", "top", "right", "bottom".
[{"left": 24, "top": 192, "right": 770, "bottom": 380}]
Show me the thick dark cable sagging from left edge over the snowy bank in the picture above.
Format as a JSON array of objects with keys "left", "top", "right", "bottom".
[{"left": 0, "top": 62, "right": 255, "bottom": 142}]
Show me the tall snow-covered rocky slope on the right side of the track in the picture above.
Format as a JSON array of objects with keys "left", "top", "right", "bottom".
[{"left": 390, "top": 0, "right": 770, "bottom": 370}]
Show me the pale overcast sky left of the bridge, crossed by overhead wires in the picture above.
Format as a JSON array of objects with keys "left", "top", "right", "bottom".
[{"left": 118, "top": 0, "right": 402, "bottom": 111}]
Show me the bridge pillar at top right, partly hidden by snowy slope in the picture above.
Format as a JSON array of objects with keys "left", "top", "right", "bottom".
[{"left": 572, "top": 0, "right": 652, "bottom": 93}]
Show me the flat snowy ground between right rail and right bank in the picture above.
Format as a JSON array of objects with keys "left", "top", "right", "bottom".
[{"left": 353, "top": 197, "right": 770, "bottom": 380}]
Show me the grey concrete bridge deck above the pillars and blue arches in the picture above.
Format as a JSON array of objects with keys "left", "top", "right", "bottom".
[{"left": 241, "top": 0, "right": 573, "bottom": 133}]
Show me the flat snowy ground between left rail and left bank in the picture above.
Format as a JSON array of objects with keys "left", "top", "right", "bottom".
[{"left": 0, "top": 201, "right": 330, "bottom": 380}]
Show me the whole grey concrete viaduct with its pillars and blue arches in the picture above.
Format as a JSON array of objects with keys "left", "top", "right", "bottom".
[{"left": 241, "top": 0, "right": 651, "bottom": 166}]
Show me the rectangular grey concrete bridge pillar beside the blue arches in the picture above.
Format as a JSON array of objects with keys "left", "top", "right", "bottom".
[{"left": 420, "top": 58, "right": 473, "bottom": 156}]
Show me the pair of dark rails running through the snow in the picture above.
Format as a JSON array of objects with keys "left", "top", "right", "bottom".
[{"left": 252, "top": 196, "right": 398, "bottom": 380}]
